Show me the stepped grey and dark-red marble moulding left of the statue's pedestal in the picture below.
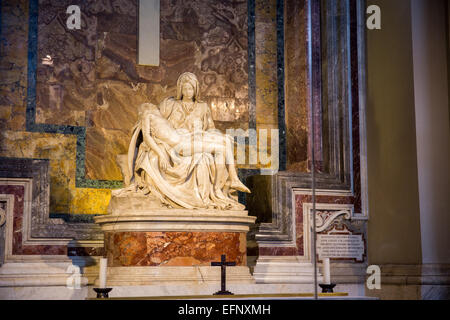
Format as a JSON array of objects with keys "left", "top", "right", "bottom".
[{"left": 0, "top": 171, "right": 103, "bottom": 262}]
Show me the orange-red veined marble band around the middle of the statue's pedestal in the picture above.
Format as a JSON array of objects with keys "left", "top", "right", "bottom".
[{"left": 105, "top": 232, "right": 246, "bottom": 267}]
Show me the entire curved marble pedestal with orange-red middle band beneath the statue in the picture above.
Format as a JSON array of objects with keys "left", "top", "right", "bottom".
[{"left": 95, "top": 209, "right": 256, "bottom": 286}]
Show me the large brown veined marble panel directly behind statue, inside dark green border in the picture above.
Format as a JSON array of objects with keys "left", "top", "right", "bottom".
[{"left": 36, "top": 0, "right": 249, "bottom": 180}]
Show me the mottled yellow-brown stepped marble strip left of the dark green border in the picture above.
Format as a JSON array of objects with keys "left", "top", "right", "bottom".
[{"left": 0, "top": 0, "right": 110, "bottom": 213}]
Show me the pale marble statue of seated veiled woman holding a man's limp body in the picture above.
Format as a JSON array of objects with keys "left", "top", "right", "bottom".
[{"left": 113, "top": 72, "right": 250, "bottom": 210}]
